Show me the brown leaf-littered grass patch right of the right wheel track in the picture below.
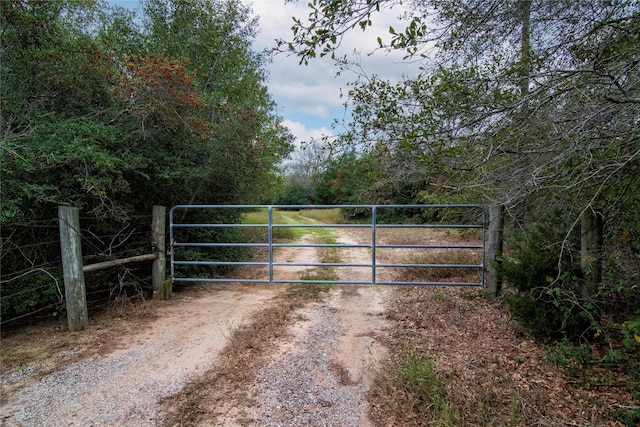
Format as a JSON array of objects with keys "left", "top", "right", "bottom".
[{"left": 370, "top": 230, "right": 637, "bottom": 426}]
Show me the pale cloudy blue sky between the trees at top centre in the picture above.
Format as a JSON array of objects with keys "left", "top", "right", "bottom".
[{"left": 108, "top": 0, "right": 418, "bottom": 150}]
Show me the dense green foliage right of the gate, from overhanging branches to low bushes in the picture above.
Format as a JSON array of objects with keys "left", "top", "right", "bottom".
[{"left": 279, "top": 0, "right": 640, "bottom": 352}]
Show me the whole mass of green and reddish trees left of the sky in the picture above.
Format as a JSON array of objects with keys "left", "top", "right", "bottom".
[{"left": 0, "top": 0, "right": 293, "bottom": 324}]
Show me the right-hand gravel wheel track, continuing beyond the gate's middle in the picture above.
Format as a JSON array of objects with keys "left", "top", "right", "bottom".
[{"left": 231, "top": 229, "right": 390, "bottom": 427}]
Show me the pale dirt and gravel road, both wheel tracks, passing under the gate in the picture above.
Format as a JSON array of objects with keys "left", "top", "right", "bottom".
[{"left": 2, "top": 229, "right": 388, "bottom": 426}]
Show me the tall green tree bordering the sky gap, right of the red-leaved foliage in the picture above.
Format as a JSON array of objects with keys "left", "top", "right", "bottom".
[{"left": 143, "top": 0, "right": 293, "bottom": 203}]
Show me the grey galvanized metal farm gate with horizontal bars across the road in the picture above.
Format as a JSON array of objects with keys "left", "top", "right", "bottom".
[{"left": 169, "top": 205, "right": 486, "bottom": 286}]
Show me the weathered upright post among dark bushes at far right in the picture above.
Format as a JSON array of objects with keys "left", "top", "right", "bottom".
[{"left": 580, "top": 208, "right": 603, "bottom": 298}]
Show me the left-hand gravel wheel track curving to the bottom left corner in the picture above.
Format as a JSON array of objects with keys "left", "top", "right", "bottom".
[{"left": 2, "top": 283, "right": 282, "bottom": 426}]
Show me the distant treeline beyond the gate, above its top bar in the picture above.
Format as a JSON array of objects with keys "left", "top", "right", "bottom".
[{"left": 279, "top": 145, "right": 460, "bottom": 209}]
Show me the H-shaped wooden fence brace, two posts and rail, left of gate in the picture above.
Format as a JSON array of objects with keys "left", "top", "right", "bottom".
[{"left": 58, "top": 206, "right": 171, "bottom": 331}]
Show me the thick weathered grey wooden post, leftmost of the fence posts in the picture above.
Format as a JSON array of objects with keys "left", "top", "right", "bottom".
[{"left": 58, "top": 206, "right": 89, "bottom": 331}]
